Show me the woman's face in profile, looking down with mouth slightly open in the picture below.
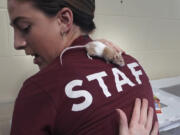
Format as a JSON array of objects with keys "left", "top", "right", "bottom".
[{"left": 8, "top": 0, "right": 63, "bottom": 69}]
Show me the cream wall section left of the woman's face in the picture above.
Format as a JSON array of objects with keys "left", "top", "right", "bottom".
[{"left": 0, "top": 0, "right": 37, "bottom": 103}]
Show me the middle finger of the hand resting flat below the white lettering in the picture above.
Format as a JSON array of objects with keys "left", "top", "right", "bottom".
[{"left": 139, "top": 99, "right": 148, "bottom": 125}]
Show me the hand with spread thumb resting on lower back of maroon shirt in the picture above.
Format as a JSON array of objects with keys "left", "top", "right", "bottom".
[{"left": 117, "top": 98, "right": 159, "bottom": 135}]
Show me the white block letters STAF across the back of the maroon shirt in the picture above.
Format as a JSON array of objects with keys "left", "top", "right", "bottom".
[{"left": 65, "top": 62, "right": 143, "bottom": 112}]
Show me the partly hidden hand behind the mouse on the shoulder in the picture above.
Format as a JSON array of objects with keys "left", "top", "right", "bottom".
[{"left": 96, "top": 39, "right": 125, "bottom": 53}]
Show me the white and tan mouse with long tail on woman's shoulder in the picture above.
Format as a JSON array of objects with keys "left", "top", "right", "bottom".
[{"left": 60, "top": 41, "right": 125, "bottom": 67}]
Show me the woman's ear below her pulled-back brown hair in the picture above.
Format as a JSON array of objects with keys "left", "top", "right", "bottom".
[{"left": 57, "top": 8, "right": 73, "bottom": 33}]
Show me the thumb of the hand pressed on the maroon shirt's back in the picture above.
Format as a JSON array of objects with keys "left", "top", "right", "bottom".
[{"left": 116, "top": 109, "right": 128, "bottom": 135}]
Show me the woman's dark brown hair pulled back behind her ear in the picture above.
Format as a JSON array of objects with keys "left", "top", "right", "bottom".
[{"left": 18, "top": 0, "right": 96, "bottom": 33}]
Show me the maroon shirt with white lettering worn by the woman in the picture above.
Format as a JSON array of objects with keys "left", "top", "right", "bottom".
[{"left": 11, "top": 36, "right": 157, "bottom": 135}]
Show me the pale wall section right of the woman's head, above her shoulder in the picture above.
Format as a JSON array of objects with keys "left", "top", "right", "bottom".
[{"left": 94, "top": 0, "right": 180, "bottom": 79}]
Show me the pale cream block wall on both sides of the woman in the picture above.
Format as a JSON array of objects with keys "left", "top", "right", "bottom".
[{"left": 0, "top": 0, "right": 180, "bottom": 102}]
